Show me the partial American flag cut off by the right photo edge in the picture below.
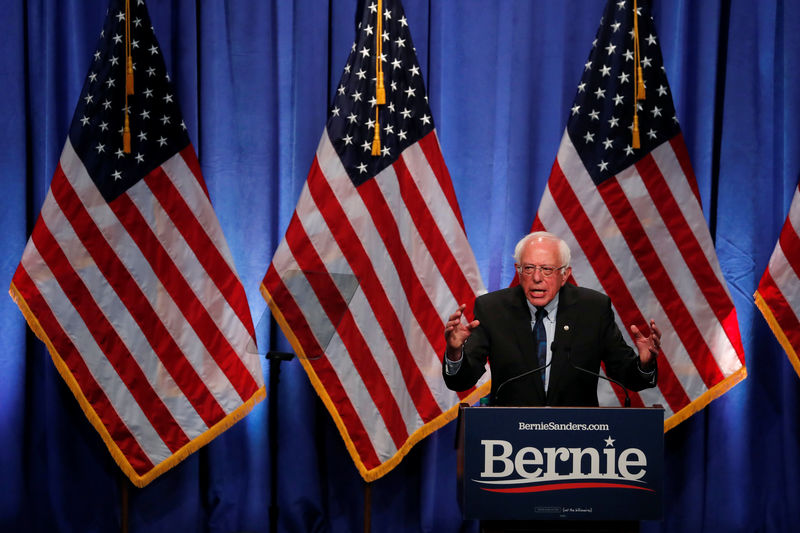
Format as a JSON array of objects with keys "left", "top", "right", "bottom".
[{"left": 754, "top": 184, "right": 800, "bottom": 375}]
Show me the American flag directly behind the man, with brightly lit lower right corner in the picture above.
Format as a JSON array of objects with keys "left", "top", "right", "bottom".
[{"left": 533, "top": 0, "right": 746, "bottom": 429}]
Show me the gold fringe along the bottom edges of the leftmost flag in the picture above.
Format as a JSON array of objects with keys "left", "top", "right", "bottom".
[{"left": 8, "top": 283, "right": 267, "bottom": 488}]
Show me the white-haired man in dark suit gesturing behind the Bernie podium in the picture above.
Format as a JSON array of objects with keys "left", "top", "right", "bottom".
[{"left": 442, "top": 232, "right": 661, "bottom": 406}]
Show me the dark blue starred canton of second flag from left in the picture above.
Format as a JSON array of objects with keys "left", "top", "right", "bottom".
[{"left": 327, "top": 0, "right": 434, "bottom": 186}]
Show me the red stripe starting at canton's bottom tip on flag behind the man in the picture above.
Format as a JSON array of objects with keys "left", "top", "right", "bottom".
[{"left": 597, "top": 177, "right": 724, "bottom": 389}]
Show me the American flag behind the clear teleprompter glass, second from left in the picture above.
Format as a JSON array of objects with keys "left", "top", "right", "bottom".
[{"left": 261, "top": 0, "right": 486, "bottom": 481}]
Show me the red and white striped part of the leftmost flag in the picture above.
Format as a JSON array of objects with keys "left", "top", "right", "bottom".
[{"left": 12, "top": 139, "right": 264, "bottom": 486}]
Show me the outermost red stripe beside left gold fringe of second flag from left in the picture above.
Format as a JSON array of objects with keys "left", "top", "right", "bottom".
[{"left": 264, "top": 264, "right": 381, "bottom": 470}]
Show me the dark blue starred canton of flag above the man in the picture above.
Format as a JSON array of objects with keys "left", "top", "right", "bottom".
[{"left": 567, "top": 0, "right": 680, "bottom": 185}]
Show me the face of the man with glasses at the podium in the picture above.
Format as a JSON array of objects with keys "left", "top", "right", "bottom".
[{"left": 516, "top": 239, "right": 572, "bottom": 307}]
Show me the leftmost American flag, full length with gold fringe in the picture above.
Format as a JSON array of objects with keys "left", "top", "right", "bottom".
[{"left": 10, "top": 0, "right": 265, "bottom": 487}]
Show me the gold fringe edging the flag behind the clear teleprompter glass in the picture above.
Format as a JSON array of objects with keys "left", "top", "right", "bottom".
[{"left": 261, "top": 283, "right": 491, "bottom": 482}]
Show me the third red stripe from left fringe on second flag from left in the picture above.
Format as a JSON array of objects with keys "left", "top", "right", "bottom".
[{"left": 307, "top": 159, "right": 442, "bottom": 422}]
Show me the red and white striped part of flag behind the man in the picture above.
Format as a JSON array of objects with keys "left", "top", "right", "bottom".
[{"left": 533, "top": 132, "right": 744, "bottom": 428}]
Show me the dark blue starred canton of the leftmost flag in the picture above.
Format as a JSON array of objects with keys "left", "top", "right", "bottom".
[{"left": 69, "top": 0, "right": 189, "bottom": 202}]
